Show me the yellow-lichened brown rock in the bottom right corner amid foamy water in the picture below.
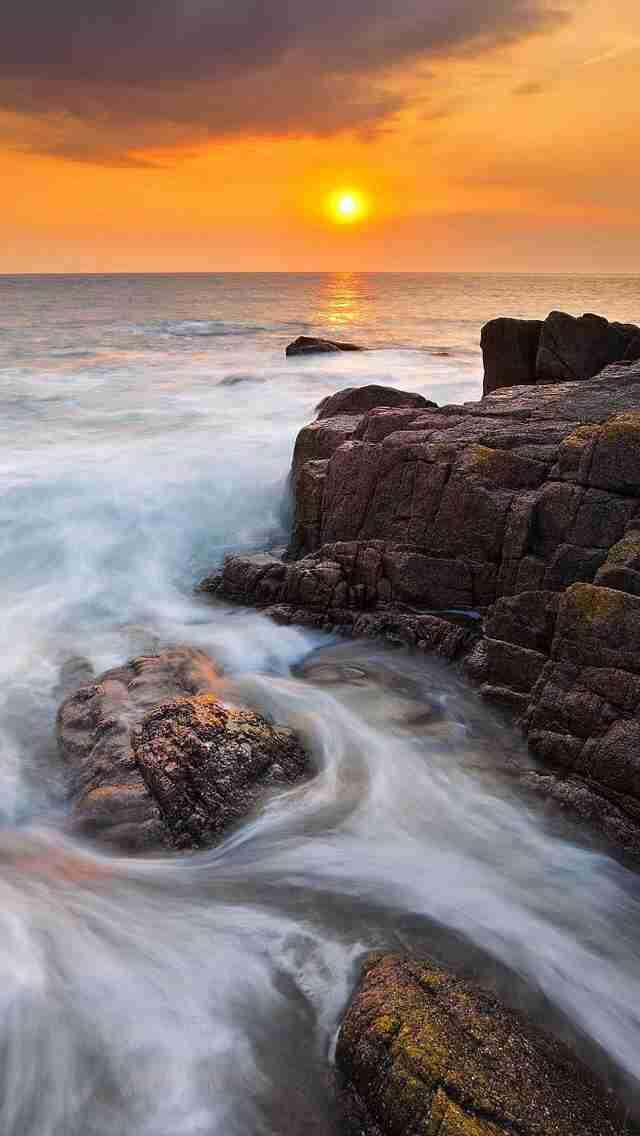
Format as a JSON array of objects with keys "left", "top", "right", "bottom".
[{"left": 336, "top": 955, "right": 640, "bottom": 1136}]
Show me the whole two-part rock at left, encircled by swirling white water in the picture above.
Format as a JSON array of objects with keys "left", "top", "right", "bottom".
[{"left": 58, "top": 648, "right": 311, "bottom": 852}]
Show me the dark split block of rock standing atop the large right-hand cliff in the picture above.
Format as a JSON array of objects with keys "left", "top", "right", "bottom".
[{"left": 481, "top": 311, "right": 640, "bottom": 395}]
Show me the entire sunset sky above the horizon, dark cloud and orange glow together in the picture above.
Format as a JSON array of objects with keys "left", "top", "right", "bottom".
[{"left": 0, "top": 0, "right": 640, "bottom": 274}]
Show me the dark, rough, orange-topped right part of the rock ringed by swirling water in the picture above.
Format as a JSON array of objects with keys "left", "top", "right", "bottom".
[{"left": 132, "top": 694, "right": 308, "bottom": 849}]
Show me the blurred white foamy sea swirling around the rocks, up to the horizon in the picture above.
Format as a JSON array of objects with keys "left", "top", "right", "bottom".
[{"left": 0, "top": 276, "right": 640, "bottom": 1136}]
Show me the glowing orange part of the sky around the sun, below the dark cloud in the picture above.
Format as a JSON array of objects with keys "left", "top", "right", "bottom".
[{"left": 0, "top": 0, "right": 640, "bottom": 273}]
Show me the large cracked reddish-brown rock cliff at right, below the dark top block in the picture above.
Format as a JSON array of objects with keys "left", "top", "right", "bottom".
[{"left": 201, "top": 361, "right": 640, "bottom": 855}]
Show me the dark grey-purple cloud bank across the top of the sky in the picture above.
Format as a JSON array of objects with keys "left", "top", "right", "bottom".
[{"left": 0, "top": 0, "right": 559, "bottom": 160}]
